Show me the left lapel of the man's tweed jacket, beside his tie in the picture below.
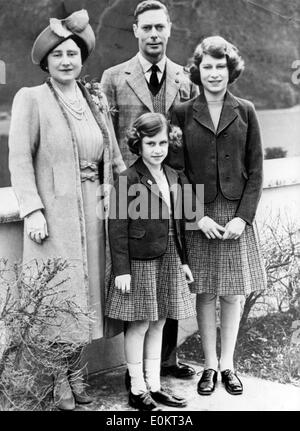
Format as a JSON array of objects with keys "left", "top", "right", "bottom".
[{"left": 125, "top": 55, "right": 154, "bottom": 112}]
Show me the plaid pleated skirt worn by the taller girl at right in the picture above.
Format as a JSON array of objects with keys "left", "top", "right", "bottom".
[{"left": 187, "top": 193, "right": 267, "bottom": 295}]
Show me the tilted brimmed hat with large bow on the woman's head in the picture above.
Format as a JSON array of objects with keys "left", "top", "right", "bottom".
[{"left": 31, "top": 9, "right": 95, "bottom": 64}]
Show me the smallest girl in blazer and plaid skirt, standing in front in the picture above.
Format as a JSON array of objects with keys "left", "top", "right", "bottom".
[{"left": 105, "top": 113, "right": 195, "bottom": 410}]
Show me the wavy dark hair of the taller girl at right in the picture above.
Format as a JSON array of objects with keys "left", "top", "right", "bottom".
[{"left": 190, "top": 36, "right": 245, "bottom": 86}]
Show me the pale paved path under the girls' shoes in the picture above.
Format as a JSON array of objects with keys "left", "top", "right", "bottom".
[{"left": 83, "top": 361, "right": 300, "bottom": 412}]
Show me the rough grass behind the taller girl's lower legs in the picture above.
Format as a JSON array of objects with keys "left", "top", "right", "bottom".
[{"left": 179, "top": 313, "right": 300, "bottom": 386}]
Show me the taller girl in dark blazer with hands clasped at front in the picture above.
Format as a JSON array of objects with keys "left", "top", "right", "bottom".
[{"left": 170, "top": 36, "right": 266, "bottom": 395}]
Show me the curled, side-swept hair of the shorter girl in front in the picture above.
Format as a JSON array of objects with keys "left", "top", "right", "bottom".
[{"left": 126, "top": 112, "right": 182, "bottom": 155}]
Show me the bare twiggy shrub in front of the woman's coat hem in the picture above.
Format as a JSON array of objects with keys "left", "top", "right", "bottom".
[{"left": 0, "top": 259, "right": 88, "bottom": 410}]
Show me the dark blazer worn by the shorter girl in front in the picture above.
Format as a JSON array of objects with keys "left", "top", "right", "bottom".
[{"left": 108, "top": 158, "right": 187, "bottom": 276}]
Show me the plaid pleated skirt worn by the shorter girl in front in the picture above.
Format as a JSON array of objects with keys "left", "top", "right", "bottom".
[{"left": 105, "top": 235, "right": 196, "bottom": 322}]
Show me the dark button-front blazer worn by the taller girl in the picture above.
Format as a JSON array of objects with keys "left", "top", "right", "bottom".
[{"left": 167, "top": 91, "right": 263, "bottom": 224}]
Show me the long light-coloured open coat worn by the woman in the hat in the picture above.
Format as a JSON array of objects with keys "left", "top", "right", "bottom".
[{"left": 9, "top": 81, "right": 125, "bottom": 342}]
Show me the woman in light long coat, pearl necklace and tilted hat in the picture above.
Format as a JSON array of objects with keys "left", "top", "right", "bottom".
[{"left": 9, "top": 10, "right": 125, "bottom": 410}]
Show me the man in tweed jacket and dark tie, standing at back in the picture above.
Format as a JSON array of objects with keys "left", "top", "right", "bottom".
[{"left": 101, "top": 0, "right": 198, "bottom": 378}]
